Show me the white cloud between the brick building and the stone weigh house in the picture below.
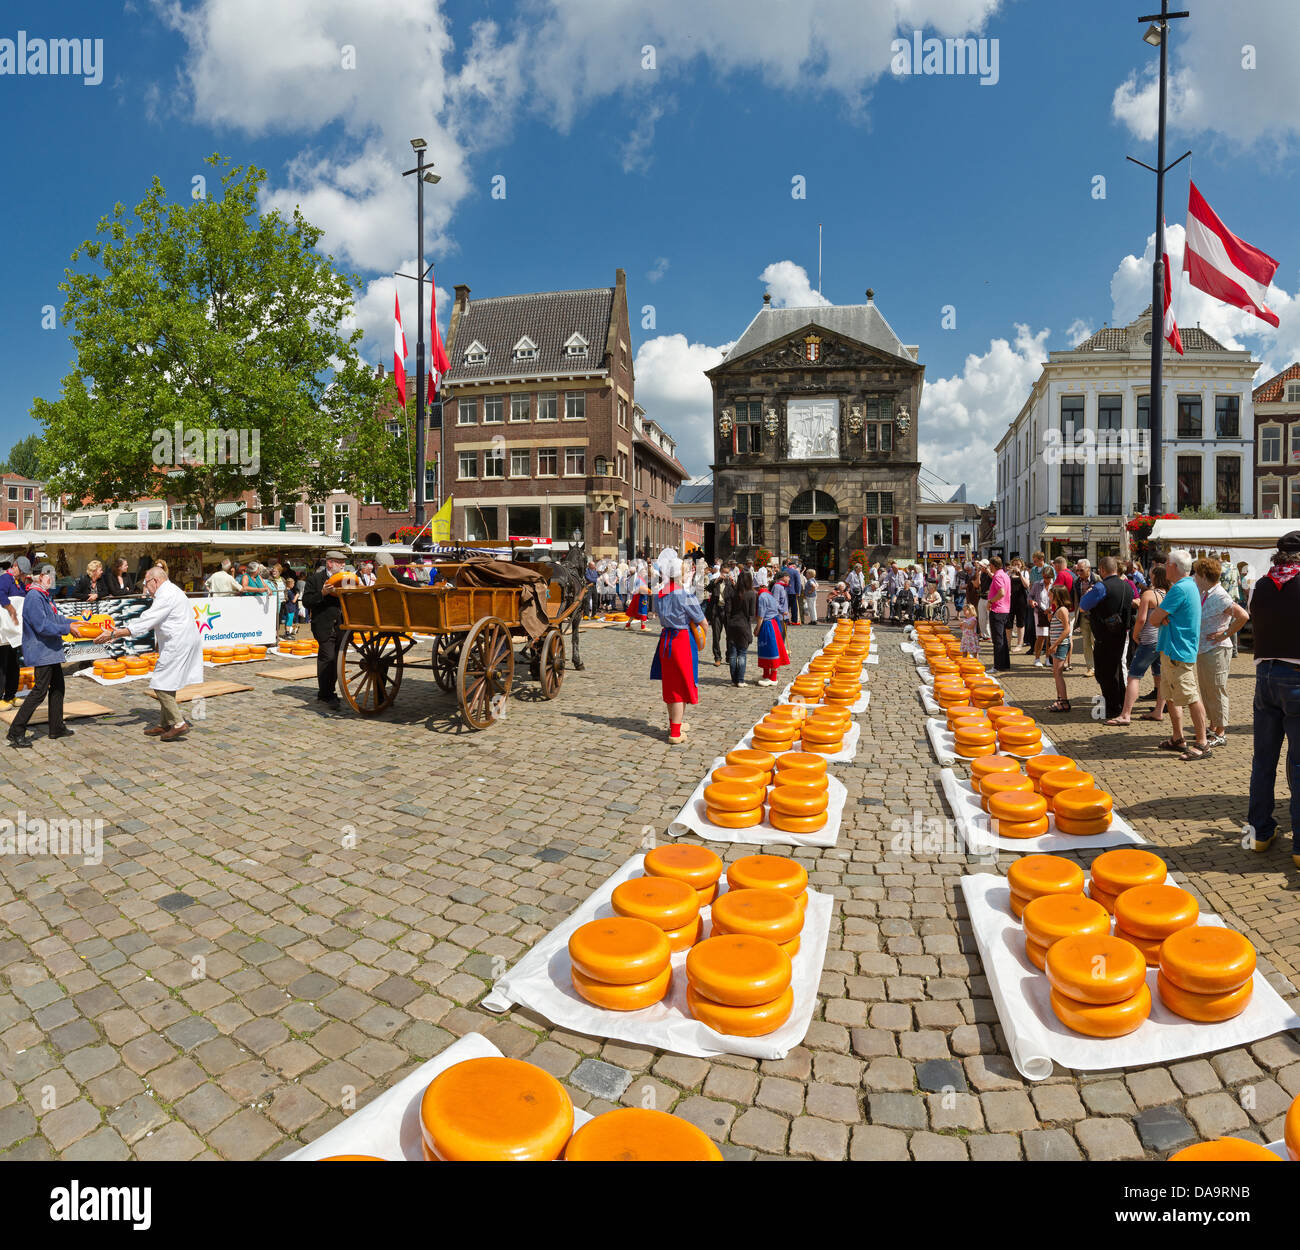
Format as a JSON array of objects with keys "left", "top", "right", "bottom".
[{"left": 634, "top": 334, "right": 732, "bottom": 476}]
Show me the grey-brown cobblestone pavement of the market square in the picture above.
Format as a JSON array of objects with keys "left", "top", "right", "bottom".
[{"left": 0, "top": 628, "right": 1300, "bottom": 1159}]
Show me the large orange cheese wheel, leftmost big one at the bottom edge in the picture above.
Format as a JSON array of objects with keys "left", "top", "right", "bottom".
[{"left": 420, "top": 1058, "right": 573, "bottom": 1162}]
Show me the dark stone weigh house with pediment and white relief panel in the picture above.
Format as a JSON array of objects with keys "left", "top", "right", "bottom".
[{"left": 707, "top": 290, "right": 926, "bottom": 578}]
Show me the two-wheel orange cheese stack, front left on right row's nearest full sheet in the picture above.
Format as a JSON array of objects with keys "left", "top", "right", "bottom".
[{"left": 1045, "top": 934, "right": 1151, "bottom": 1037}]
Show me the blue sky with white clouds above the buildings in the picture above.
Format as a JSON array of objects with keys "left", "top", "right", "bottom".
[{"left": 0, "top": 0, "right": 1300, "bottom": 502}]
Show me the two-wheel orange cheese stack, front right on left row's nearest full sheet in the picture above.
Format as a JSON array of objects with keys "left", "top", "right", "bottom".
[{"left": 686, "top": 935, "right": 794, "bottom": 1037}]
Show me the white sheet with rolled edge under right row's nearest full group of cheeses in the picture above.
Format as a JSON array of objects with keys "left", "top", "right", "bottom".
[{"left": 961, "top": 872, "right": 1300, "bottom": 1081}]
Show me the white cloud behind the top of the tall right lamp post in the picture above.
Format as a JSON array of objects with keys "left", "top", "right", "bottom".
[{"left": 1112, "top": 0, "right": 1300, "bottom": 143}]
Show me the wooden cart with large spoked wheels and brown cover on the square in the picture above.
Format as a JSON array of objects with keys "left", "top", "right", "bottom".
[{"left": 337, "top": 548, "right": 585, "bottom": 729}]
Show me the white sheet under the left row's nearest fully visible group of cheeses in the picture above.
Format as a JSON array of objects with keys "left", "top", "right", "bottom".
[{"left": 480, "top": 855, "right": 833, "bottom": 1059}]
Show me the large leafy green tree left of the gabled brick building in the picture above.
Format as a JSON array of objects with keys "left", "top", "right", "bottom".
[{"left": 33, "top": 155, "right": 410, "bottom": 528}]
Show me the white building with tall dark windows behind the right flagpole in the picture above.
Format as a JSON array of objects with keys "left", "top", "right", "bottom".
[{"left": 997, "top": 309, "right": 1260, "bottom": 564}]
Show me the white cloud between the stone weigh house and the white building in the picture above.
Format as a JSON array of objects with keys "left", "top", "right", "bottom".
[{"left": 918, "top": 324, "right": 1052, "bottom": 504}]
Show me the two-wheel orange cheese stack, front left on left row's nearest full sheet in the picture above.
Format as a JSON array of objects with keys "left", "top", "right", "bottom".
[{"left": 569, "top": 916, "right": 672, "bottom": 1011}]
